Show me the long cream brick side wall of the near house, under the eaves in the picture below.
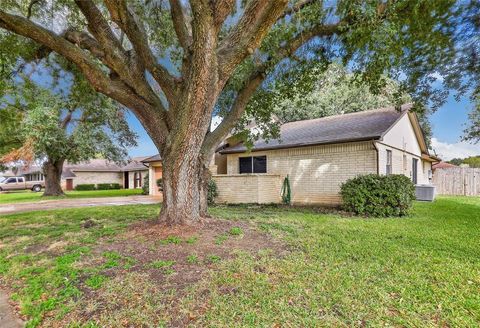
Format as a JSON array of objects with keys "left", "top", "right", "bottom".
[{"left": 223, "top": 142, "right": 377, "bottom": 205}]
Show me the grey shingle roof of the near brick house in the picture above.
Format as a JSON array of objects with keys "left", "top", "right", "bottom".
[{"left": 220, "top": 105, "right": 411, "bottom": 154}]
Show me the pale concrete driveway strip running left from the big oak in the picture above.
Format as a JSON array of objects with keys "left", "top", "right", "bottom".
[{"left": 0, "top": 196, "right": 162, "bottom": 215}]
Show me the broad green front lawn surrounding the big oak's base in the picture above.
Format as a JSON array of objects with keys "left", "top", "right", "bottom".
[{"left": 0, "top": 197, "right": 480, "bottom": 327}]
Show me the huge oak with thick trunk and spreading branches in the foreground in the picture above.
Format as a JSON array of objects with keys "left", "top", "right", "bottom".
[{"left": 0, "top": 0, "right": 466, "bottom": 224}]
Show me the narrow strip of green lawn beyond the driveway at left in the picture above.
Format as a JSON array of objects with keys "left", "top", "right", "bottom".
[{"left": 0, "top": 189, "right": 142, "bottom": 204}]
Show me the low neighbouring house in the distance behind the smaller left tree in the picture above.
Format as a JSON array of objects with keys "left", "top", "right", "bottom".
[{"left": 5, "top": 157, "right": 148, "bottom": 190}]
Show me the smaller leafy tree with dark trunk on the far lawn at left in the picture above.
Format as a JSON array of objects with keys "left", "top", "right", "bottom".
[{"left": 0, "top": 75, "right": 136, "bottom": 196}]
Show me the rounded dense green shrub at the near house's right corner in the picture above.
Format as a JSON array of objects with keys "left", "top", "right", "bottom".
[{"left": 340, "top": 174, "right": 415, "bottom": 217}]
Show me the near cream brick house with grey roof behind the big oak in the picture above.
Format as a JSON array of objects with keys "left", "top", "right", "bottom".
[{"left": 144, "top": 105, "right": 439, "bottom": 204}]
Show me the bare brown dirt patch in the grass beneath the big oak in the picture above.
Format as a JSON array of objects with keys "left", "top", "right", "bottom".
[{"left": 57, "top": 219, "right": 288, "bottom": 327}]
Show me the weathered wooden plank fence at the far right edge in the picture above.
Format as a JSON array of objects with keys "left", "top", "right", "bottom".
[{"left": 433, "top": 167, "right": 480, "bottom": 196}]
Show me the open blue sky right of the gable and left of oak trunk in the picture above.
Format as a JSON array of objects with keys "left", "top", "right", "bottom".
[{"left": 128, "top": 96, "right": 480, "bottom": 160}]
